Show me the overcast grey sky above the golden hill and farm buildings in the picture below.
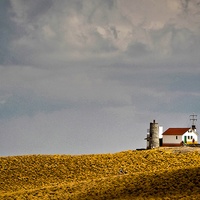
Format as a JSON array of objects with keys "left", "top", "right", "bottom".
[{"left": 0, "top": 0, "right": 200, "bottom": 156}]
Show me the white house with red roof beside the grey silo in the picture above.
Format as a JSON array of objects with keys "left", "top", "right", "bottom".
[{"left": 162, "top": 125, "right": 198, "bottom": 147}]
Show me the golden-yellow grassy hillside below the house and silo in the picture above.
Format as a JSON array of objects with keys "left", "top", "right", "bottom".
[{"left": 0, "top": 147, "right": 200, "bottom": 200}]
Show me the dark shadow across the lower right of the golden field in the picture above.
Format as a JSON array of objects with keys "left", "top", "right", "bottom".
[{"left": 76, "top": 168, "right": 200, "bottom": 199}]
